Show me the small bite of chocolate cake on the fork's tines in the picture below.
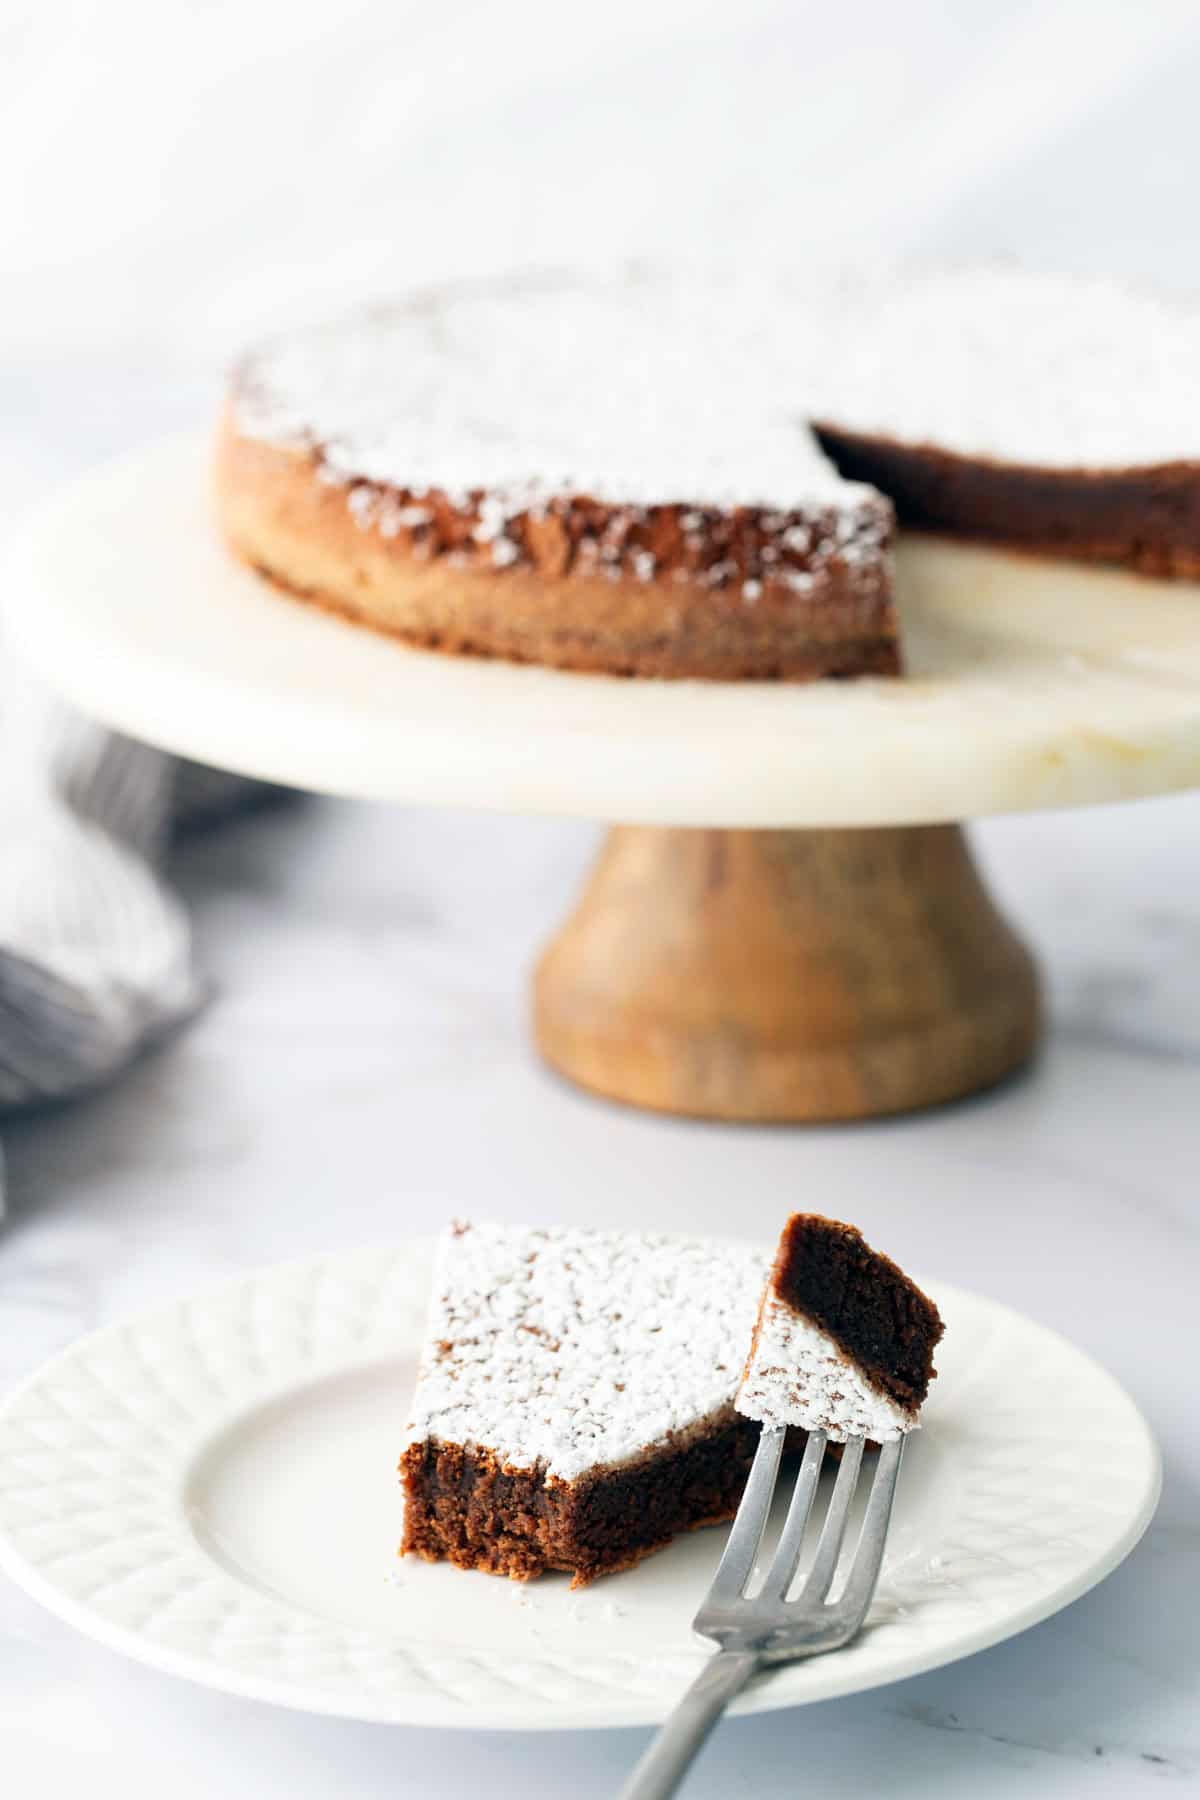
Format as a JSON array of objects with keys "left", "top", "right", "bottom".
[{"left": 738, "top": 1213, "right": 943, "bottom": 1444}]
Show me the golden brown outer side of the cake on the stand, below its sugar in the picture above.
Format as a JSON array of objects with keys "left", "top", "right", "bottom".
[{"left": 216, "top": 407, "right": 900, "bottom": 680}]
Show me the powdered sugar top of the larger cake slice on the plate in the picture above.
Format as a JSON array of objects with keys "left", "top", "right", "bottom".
[{"left": 399, "top": 1224, "right": 768, "bottom": 1481}]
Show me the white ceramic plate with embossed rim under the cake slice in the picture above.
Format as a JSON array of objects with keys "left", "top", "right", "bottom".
[{"left": 0, "top": 1242, "right": 1159, "bottom": 1728}]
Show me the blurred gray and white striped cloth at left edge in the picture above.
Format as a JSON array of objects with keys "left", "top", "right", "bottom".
[{"left": 0, "top": 676, "right": 282, "bottom": 1213}]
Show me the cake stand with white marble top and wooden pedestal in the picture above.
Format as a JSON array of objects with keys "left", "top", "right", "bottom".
[{"left": 4, "top": 439, "right": 1200, "bottom": 1120}]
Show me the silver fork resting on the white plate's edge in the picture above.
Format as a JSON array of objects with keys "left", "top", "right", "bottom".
[{"left": 621, "top": 1426, "right": 905, "bottom": 1800}]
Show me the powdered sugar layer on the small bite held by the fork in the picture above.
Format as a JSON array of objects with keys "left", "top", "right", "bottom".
[{"left": 738, "top": 1294, "right": 918, "bottom": 1444}]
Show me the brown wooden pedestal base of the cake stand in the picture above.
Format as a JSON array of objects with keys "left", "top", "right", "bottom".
[{"left": 534, "top": 824, "right": 1038, "bottom": 1121}]
